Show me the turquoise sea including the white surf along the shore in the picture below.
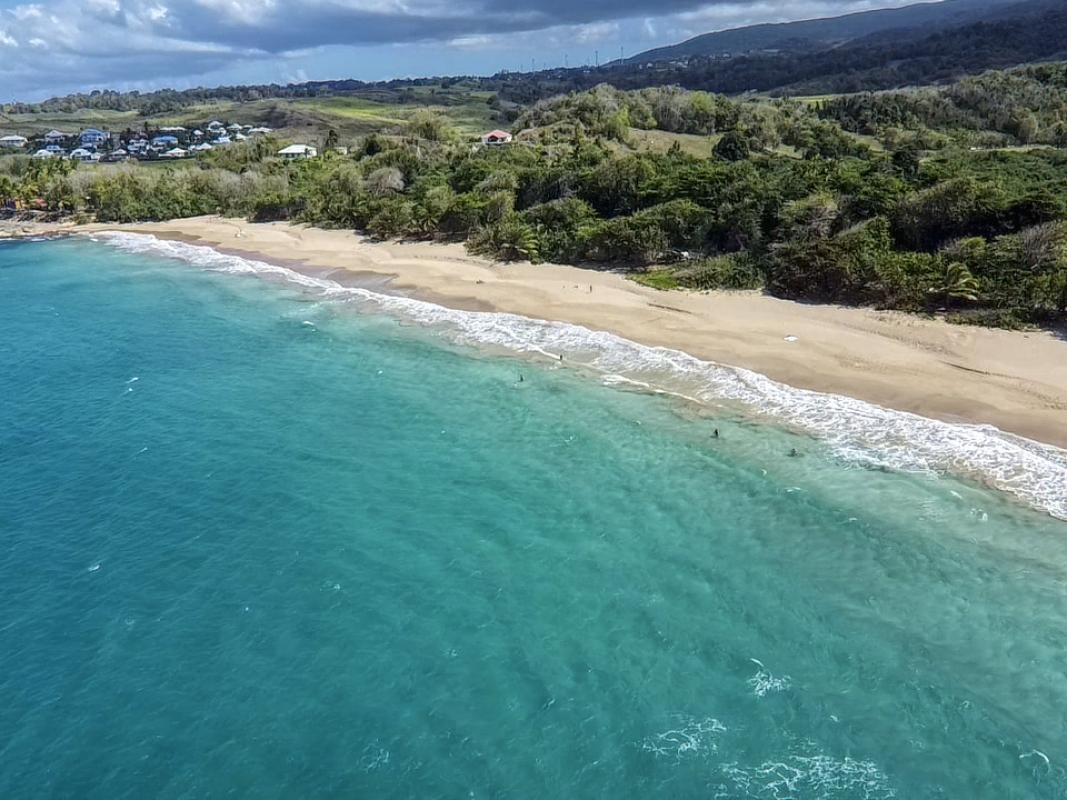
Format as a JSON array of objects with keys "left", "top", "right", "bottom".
[{"left": 0, "top": 238, "right": 1067, "bottom": 800}]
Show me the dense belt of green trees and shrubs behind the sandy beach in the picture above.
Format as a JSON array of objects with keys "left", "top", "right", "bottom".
[{"left": 0, "top": 64, "right": 1067, "bottom": 326}]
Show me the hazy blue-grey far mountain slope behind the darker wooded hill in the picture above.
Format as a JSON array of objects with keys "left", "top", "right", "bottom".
[{"left": 624, "top": 0, "right": 1020, "bottom": 64}]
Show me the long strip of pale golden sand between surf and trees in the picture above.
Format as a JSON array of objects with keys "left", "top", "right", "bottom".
[{"left": 6, "top": 218, "right": 1067, "bottom": 447}]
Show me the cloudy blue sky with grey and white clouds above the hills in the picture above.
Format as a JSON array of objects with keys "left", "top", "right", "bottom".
[{"left": 0, "top": 0, "right": 915, "bottom": 102}]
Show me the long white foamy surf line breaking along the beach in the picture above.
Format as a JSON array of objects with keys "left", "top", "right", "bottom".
[{"left": 100, "top": 233, "right": 1067, "bottom": 519}]
